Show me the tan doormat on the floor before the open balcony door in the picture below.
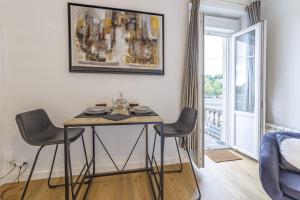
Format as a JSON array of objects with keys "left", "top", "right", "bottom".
[{"left": 205, "top": 149, "right": 242, "bottom": 163}]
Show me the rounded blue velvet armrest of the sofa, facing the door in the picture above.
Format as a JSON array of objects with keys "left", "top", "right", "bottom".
[{"left": 259, "top": 133, "right": 283, "bottom": 200}]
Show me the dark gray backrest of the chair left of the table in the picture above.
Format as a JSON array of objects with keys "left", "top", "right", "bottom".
[{"left": 16, "top": 109, "right": 54, "bottom": 145}]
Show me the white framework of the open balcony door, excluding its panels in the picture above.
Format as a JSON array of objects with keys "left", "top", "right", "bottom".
[{"left": 228, "top": 21, "right": 266, "bottom": 160}]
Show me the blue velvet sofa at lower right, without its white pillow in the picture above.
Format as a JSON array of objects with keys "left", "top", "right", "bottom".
[{"left": 259, "top": 132, "right": 300, "bottom": 200}]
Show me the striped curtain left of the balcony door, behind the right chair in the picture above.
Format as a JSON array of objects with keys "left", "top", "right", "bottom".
[{"left": 180, "top": 0, "right": 200, "bottom": 150}]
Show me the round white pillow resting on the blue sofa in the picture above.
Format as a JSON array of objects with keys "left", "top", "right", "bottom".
[{"left": 276, "top": 132, "right": 300, "bottom": 172}]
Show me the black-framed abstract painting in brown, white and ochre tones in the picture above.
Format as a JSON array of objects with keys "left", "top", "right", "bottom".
[{"left": 68, "top": 3, "right": 164, "bottom": 75}]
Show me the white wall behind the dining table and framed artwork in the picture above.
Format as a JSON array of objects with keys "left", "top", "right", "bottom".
[{"left": 0, "top": 0, "right": 188, "bottom": 181}]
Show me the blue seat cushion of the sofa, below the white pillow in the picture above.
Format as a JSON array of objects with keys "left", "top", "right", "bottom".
[{"left": 280, "top": 170, "right": 300, "bottom": 200}]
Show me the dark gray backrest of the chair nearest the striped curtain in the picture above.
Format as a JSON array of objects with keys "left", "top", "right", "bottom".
[{"left": 176, "top": 107, "right": 198, "bottom": 134}]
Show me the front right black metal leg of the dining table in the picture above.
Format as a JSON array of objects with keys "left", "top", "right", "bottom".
[{"left": 159, "top": 123, "right": 165, "bottom": 200}]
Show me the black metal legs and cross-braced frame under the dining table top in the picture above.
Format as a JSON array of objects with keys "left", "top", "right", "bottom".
[{"left": 64, "top": 122, "right": 165, "bottom": 200}]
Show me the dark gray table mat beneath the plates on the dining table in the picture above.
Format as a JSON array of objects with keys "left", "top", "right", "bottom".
[{"left": 75, "top": 111, "right": 158, "bottom": 121}]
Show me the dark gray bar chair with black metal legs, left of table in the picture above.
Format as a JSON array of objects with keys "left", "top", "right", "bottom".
[{"left": 16, "top": 109, "right": 88, "bottom": 200}]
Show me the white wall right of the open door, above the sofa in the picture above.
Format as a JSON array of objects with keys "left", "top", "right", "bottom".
[{"left": 262, "top": 0, "right": 300, "bottom": 129}]
